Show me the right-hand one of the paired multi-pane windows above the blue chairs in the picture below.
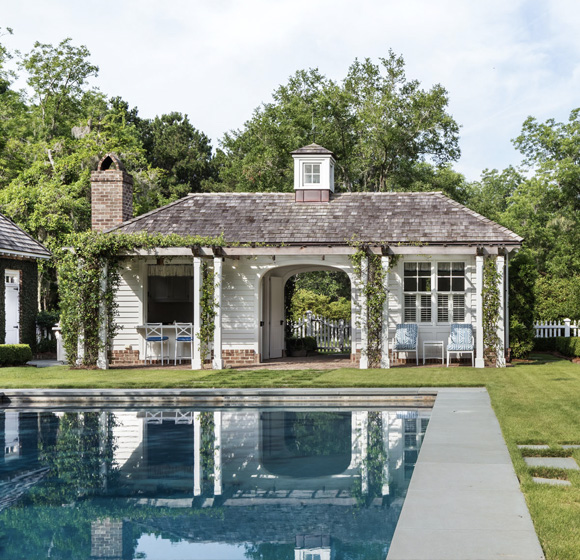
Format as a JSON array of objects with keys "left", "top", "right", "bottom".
[{"left": 437, "top": 262, "right": 465, "bottom": 323}]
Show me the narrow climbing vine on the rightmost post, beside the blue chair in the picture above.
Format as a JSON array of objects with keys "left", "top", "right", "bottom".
[{"left": 482, "top": 257, "right": 502, "bottom": 365}]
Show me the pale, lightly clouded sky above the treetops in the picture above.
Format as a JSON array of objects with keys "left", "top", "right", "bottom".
[{"left": 0, "top": 0, "right": 580, "bottom": 181}]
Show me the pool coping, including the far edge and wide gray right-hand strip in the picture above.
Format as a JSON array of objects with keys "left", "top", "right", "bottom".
[{"left": 0, "top": 387, "right": 545, "bottom": 560}]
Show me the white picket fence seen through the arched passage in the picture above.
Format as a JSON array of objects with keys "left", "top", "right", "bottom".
[{"left": 290, "top": 311, "right": 352, "bottom": 352}]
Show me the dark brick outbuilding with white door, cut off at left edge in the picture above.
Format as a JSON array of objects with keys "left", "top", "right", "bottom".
[{"left": 0, "top": 214, "right": 50, "bottom": 348}]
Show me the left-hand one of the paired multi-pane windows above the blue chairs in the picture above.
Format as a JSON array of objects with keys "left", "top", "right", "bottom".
[{"left": 403, "top": 262, "right": 431, "bottom": 323}]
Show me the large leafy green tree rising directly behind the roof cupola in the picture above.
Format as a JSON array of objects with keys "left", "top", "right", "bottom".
[{"left": 211, "top": 52, "right": 463, "bottom": 196}]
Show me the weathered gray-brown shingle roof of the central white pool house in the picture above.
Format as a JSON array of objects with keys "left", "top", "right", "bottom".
[{"left": 110, "top": 192, "right": 522, "bottom": 245}]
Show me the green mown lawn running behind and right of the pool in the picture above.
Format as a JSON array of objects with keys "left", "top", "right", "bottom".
[{"left": 0, "top": 354, "right": 580, "bottom": 560}]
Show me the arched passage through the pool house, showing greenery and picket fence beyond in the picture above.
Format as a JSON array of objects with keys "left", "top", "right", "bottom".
[{"left": 260, "top": 264, "right": 353, "bottom": 360}]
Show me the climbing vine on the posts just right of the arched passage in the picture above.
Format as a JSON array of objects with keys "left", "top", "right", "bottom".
[{"left": 350, "top": 241, "right": 397, "bottom": 368}]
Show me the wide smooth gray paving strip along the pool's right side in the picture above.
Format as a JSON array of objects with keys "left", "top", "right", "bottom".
[{"left": 387, "top": 388, "right": 544, "bottom": 560}]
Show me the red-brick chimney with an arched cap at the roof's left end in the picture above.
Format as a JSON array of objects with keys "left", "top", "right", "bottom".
[{"left": 91, "top": 154, "right": 133, "bottom": 231}]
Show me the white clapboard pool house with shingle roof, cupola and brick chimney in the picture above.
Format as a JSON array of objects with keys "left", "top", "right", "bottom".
[{"left": 92, "top": 144, "right": 522, "bottom": 368}]
